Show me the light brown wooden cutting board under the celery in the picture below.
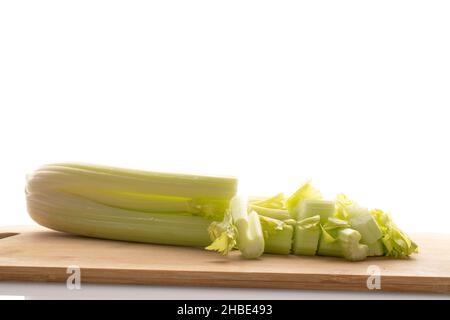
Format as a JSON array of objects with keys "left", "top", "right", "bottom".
[{"left": 0, "top": 226, "right": 450, "bottom": 294}]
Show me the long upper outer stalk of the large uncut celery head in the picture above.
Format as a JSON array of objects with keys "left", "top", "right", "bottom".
[{"left": 27, "top": 163, "right": 237, "bottom": 220}]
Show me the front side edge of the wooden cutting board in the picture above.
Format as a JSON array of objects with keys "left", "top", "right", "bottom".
[{"left": 0, "top": 266, "right": 450, "bottom": 294}]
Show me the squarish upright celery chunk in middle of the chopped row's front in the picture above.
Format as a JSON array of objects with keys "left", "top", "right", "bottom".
[{"left": 292, "top": 215, "right": 321, "bottom": 256}]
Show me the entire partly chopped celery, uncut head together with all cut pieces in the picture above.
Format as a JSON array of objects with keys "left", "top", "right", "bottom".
[{"left": 26, "top": 163, "right": 417, "bottom": 261}]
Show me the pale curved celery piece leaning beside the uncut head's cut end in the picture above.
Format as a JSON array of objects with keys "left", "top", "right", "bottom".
[{"left": 230, "top": 195, "right": 264, "bottom": 258}]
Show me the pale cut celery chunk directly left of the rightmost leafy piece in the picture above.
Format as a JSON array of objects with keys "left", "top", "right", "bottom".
[{"left": 345, "top": 205, "right": 382, "bottom": 244}]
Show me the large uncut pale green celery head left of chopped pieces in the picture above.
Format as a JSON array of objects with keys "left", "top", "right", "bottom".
[{"left": 26, "top": 163, "right": 237, "bottom": 247}]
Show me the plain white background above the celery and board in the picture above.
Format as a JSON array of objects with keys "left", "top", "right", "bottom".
[{"left": 0, "top": 0, "right": 450, "bottom": 232}]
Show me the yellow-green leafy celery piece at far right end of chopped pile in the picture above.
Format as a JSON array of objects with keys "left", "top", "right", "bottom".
[{"left": 370, "top": 209, "right": 418, "bottom": 258}]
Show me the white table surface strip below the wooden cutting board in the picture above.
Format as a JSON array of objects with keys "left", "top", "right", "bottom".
[{"left": 0, "top": 282, "right": 450, "bottom": 300}]
